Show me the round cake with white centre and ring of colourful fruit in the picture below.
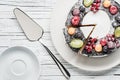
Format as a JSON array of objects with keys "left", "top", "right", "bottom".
[{"left": 63, "top": 0, "right": 120, "bottom": 57}]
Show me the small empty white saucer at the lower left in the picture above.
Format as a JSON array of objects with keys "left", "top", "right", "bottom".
[{"left": 0, "top": 46, "right": 40, "bottom": 80}]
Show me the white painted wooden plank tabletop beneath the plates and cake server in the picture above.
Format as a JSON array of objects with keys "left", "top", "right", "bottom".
[{"left": 0, "top": 0, "right": 120, "bottom": 80}]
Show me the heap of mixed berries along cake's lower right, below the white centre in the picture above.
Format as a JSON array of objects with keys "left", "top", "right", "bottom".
[{"left": 84, "top": 34, "right": 120, "bottom": 54}]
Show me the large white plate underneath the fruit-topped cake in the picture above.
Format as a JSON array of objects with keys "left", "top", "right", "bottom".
[{"left": 50, "top": 0, "right": 120, "bottom": 71}]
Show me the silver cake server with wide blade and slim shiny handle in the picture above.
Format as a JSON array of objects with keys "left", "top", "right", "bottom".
[{"left": 14, "top": 8, "right": 70, "bottom": 79}]
